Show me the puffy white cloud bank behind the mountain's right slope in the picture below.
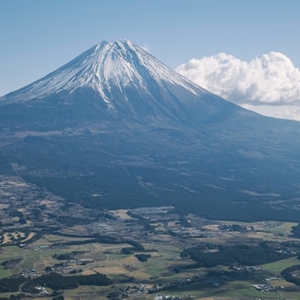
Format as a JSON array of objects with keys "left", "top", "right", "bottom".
[{"left": 176, "top": 52, "right": 300, "bottom": 120}]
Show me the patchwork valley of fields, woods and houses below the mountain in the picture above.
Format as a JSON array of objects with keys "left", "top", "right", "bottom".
[{"left": 0, "top": 176, "right": 300, "bottom": 300}]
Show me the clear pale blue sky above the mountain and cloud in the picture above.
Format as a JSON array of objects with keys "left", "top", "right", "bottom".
[{"left": 0, "top": 0, "right": 300, "bottom": 96}]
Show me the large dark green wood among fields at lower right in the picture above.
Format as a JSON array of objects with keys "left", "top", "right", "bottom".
[{"left": 177, "top": 242, "right": 293, "bottom": 268}]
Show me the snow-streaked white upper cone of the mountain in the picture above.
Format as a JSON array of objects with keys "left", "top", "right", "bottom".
[{"left": 0, "top": 40, "right": 207, "bottom": 108}]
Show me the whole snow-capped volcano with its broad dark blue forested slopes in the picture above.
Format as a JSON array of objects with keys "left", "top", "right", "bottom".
[{"left": 0, "top": 41, "right": 300, "bottom": 221}]
